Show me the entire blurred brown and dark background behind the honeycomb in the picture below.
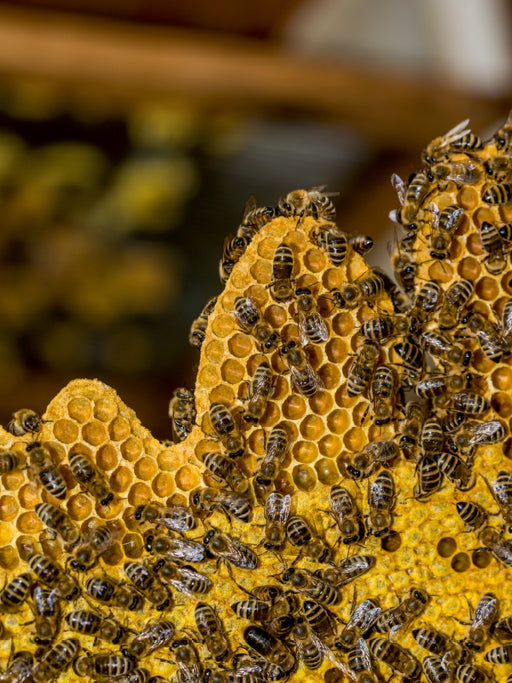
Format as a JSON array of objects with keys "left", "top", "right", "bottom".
[{"left": 0, "top": 0, "right": 512, "bottom": 438}]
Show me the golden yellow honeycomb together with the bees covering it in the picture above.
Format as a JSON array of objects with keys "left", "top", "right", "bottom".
[{"left": 0, "top": 122, "right": 512, "bottom": 683}]
